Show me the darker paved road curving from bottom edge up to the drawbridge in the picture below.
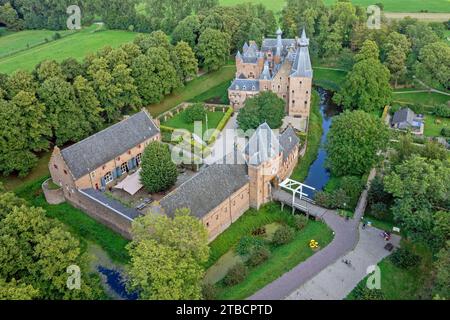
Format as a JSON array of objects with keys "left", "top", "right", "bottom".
[{"left": 249, "top": 170, "right": 375, "bottom": 300}]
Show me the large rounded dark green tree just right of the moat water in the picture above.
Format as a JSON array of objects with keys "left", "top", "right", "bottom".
[{"left": 326, "top": 111, "right": 389, "bottom": 176}]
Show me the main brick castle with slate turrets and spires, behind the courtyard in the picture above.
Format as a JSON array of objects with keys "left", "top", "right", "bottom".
[{"left": 228, "top": 29, "right": 313, "bottom": 119}]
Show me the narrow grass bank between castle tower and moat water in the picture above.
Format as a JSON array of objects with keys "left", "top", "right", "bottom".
[{"left": 291, "top": 91, "right": 323, "bottom": 181}]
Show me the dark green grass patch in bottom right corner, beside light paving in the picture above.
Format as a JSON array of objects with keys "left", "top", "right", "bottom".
[{"left": 347, "top": 240, "right": 432, "bottom": 300}]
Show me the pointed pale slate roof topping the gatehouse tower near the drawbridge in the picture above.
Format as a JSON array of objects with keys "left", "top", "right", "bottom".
[{"left": 244, "top": 122, "right": 282, "bottom": 165}]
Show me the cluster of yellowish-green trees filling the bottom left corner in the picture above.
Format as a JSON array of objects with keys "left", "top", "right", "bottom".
[{"left": 0, "top": 186, "right": 103, "bottom": 300}]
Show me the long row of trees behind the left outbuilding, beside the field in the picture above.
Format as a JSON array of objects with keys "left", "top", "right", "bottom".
[{"left": 0, "top": 31, "right": 198, "bottom": 176}]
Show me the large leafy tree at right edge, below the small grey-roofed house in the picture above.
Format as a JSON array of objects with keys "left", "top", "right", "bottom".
[{"left": 384, "top": 155, "right": 450, "bottom": 250}]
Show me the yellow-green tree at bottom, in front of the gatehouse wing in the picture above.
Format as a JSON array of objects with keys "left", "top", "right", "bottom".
[{"left": 127, "top": 209, "right": 209, "bottom": 300}]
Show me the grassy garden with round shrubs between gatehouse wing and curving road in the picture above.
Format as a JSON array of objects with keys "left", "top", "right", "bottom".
[{"left": 204, "top": 203, "right": 333, "bottom": 299}]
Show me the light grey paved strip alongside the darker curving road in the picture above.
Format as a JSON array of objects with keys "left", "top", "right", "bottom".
[{"left": 287, "top": 228, "right": 400, "bottom": 300}]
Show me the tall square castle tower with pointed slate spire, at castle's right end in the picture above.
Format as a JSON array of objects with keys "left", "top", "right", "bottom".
[{"left": 288, "top": 29, "right": 313, "bottom": 119}]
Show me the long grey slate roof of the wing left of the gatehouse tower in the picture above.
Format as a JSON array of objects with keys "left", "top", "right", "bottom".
[{"left": 159, "top": 163, "right": 249, "bottom": 219}]
